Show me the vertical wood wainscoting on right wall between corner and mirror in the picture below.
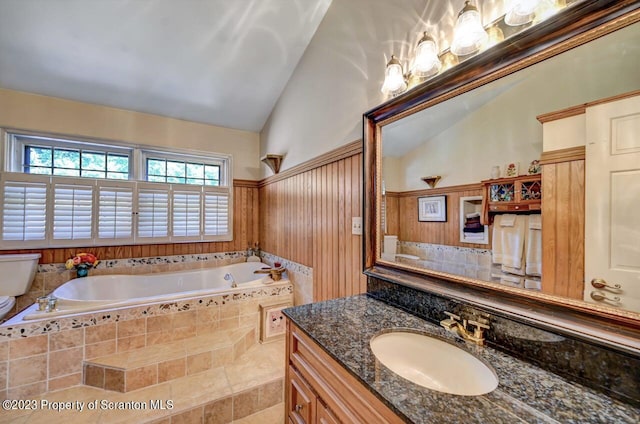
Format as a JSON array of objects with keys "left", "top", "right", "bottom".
[{"left": 260, "top": 141, "right": 366, "bottom": 301}]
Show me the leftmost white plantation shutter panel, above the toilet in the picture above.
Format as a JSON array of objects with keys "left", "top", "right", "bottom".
[{"left": 0, "top": 173, "right": 49, "bottom": 246}]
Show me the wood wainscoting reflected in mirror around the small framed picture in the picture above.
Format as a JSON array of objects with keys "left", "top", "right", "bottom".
[{"left": 386, "top": 184, "right": 491, "bottom": 249}]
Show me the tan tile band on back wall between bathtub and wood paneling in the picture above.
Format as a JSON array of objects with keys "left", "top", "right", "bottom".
[{"left": 5, "top": 251, "right": 246, "bottom": 320}]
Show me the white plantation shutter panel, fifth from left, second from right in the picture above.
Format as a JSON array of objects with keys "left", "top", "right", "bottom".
[{"left": 172, "top": 186, "right": 202, "bottom": 240}]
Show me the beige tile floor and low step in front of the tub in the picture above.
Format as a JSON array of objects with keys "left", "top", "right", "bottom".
[{"left": 0, "top": 339, "right": 285, "bottom": 424}]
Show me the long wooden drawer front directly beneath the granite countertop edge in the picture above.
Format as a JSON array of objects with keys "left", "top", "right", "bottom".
[{"left": 287, "top": 321, "right": 404, "bottom": 424}]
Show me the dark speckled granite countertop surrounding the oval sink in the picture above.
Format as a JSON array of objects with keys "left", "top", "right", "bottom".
[{"left": 284, "top": 295, "right": 640, "bottom": 424}]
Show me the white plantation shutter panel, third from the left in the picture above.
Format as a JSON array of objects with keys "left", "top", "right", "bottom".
[{"left": 98, "top": 182, "right": 135, "bottom": 242}]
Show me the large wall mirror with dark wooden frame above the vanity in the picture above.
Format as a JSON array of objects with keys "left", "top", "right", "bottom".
[{"left": 364, "top": 2, "right": 640, "bottom": 328}]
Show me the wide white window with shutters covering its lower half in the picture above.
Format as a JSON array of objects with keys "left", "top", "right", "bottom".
[{"left": 0, "top": 134, "right": 232, "bottom": 248}]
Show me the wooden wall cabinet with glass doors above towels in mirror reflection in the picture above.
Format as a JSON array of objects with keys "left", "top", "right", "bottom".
[{"left": 482, "top": 174, "right": 542, "bottom": 225}]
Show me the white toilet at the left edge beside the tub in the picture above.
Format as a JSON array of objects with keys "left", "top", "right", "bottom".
[{"left": 0, "top": 253, "right": 40, "bottom": 320}]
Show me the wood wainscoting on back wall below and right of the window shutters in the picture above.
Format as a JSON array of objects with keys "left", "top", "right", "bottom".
[{"left": 2, "top": 180, "right": 260, "bottom": 264}]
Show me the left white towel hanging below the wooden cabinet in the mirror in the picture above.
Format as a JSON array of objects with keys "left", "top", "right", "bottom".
[{"left": 492, "top": 215, "right": 528, "bottom": 268}]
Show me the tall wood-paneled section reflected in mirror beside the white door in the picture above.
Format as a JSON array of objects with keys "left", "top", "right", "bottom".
[{"left": 540, "top": 146, "right": 585, "bottom": 300}]
